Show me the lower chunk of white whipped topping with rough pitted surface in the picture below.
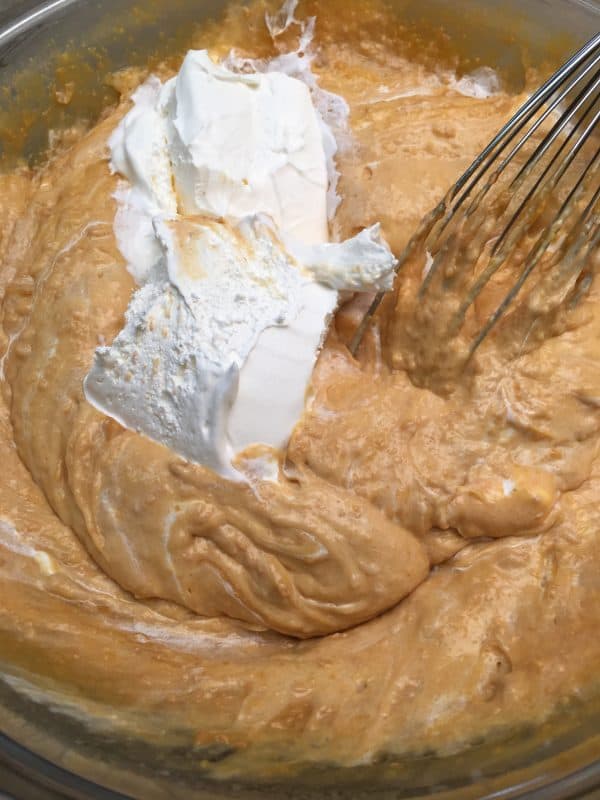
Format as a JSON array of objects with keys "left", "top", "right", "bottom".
[{"left": 85, "top": 218, "right": 336, "bottom": 474}]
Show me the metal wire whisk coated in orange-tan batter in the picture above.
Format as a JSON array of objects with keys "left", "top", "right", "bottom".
[{"left": 350, "top": 34, "right": 600, "bottom": 361}]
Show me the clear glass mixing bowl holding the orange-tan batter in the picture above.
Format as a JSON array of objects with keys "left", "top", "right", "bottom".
[{"left": 0, "top": 0, "right": 600, "bottom": 800}]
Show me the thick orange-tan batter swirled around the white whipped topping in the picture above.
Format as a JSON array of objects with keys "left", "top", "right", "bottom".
[{"left": 0, "top": 0, "right": 600, "bottom": 779}]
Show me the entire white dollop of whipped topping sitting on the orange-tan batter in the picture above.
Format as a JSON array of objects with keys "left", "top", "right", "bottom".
[{"left": 84, "top": 51, "right": 396, "bottom": 479}]
